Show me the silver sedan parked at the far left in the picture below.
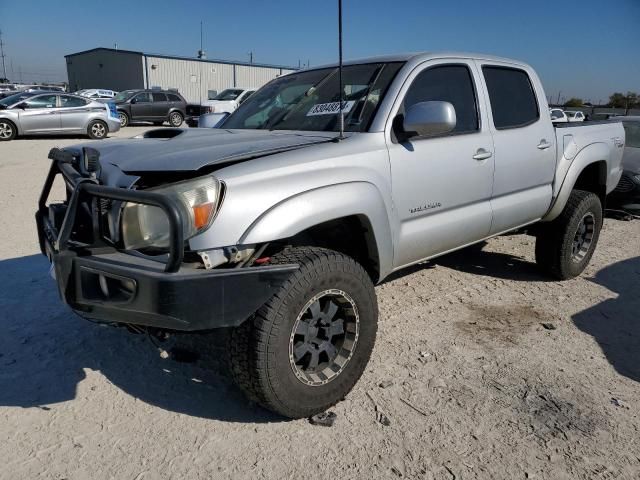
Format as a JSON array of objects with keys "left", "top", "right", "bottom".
[{"left": 0, "top": 92, "right": 120, "bottom": 141}]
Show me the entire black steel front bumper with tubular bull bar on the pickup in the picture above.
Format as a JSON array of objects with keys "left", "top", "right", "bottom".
[{"left": 36, "top": 150, "right": 298, "bottom": 331}]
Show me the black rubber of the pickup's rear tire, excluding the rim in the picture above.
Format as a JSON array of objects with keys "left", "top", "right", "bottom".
[{"left": 536, "top": 190, "right": 603, "bottom": 280}]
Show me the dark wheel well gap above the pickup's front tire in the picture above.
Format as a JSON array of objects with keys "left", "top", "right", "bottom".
[{"left": 287, "top": 215, "right": 380, "bottom": 283}]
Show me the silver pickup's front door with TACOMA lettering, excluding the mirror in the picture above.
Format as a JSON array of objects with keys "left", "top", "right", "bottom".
[{"left": 387, "top": 60, "right": 494, "bottom": 268}]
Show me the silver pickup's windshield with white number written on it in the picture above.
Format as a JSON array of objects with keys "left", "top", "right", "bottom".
[{"left": 222, "top": 62, "right": 403, "bottom": 132}]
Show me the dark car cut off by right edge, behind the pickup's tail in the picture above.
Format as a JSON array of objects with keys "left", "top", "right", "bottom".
[{"left": 609, "top": 116, "right": 640, "bottom": 210}]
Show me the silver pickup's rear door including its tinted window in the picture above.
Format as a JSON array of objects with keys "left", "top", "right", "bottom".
[{"left": 477, "top": 61, "right": 556, "bottom": 234}]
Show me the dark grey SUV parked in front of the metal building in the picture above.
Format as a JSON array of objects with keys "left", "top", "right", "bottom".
[{"left": 113, "top": 90, "right": 187, "bottom": 127}]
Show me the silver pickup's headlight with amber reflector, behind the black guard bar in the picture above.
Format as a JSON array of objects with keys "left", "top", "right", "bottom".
[{"left": 122, "top": 176, "right": 220, "bottom": 250}]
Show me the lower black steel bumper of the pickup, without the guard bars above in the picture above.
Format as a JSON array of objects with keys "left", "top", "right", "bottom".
[{"left": 45, "top": 248, "right": 298, "bottom": 331}]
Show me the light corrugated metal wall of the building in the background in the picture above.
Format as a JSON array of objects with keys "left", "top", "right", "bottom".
[{"left": 146, "top": 56, "right": 293, "bottom": 103}]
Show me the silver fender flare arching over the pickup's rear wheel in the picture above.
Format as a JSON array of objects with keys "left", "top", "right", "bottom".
[{"left": 542, "top": 142, "right": 610, "bottom": 222}]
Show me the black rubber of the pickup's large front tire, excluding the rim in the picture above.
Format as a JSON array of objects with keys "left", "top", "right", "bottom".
[{"left": 227, "top": 247, "right": 378, "bottom": 418}]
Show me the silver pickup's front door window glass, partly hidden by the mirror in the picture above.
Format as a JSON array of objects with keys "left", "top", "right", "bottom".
[{"left": 400, "top": 65, "right": 479, "bottom": 134}]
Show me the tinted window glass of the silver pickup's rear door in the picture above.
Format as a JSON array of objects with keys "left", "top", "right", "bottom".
[{"left": 482, "top": 67, "right": 540, "bottom": 129}]
